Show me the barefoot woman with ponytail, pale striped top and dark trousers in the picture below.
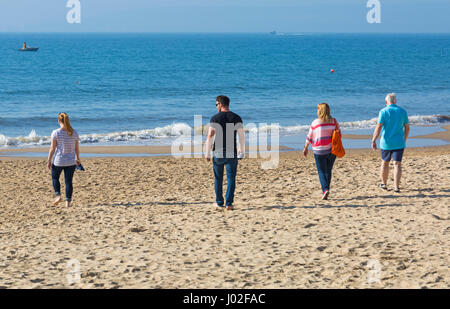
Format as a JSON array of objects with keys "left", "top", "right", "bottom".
[{"left": 47, "top": 113, "right": 81, "bottom": 207}]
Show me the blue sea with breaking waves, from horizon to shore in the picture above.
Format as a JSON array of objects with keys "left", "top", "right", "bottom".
[{"left": 0, "top": 33, "right": 450, "bottom": 147}]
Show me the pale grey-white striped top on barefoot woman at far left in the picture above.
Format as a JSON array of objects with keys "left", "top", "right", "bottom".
[{"left": 52, "top": 129, "right": 80, "bottom": 166}]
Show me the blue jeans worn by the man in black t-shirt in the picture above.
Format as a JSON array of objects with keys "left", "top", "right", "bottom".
[{"left": 213, "top": 157, "right": 238, "bottom": 206}]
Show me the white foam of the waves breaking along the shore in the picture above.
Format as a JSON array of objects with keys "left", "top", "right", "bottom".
[{"left": 0, "top": 115, "right": 450, "bottom": 147}]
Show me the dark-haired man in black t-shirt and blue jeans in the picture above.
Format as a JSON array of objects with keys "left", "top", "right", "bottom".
[{"left": 206, "top": 95, "right": 245, "bottom": 210}]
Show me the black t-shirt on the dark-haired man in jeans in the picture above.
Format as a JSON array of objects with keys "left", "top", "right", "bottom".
[{"left": 210, "top": 112, "right": 244, "bottom": 158}]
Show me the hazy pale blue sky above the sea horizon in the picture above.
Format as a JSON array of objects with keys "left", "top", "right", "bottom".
[{"left": 0, "top": 0, "right": 450, "bottom": 33}]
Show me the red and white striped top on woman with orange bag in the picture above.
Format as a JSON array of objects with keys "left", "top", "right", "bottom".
[{"left": 306, "top": 118, "right": 340, "bottom": 155}]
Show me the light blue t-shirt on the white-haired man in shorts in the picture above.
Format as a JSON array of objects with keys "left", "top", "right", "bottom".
[{"left": 378, "top": 104, "right": 409, "bottom": 150}]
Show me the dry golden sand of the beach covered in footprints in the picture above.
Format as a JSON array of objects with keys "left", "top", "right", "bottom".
[{"left": 0, "top": 146, "right": 450, "bottom": 288}]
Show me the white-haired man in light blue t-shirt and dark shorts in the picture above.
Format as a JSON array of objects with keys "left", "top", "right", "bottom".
[{"left": 372, "top": 93, "right": 409, "bottom": 193}]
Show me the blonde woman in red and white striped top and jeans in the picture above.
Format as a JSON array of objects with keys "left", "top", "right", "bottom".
[{"left": 303, "top": 103, "right": 340, "bottom": 200}]
